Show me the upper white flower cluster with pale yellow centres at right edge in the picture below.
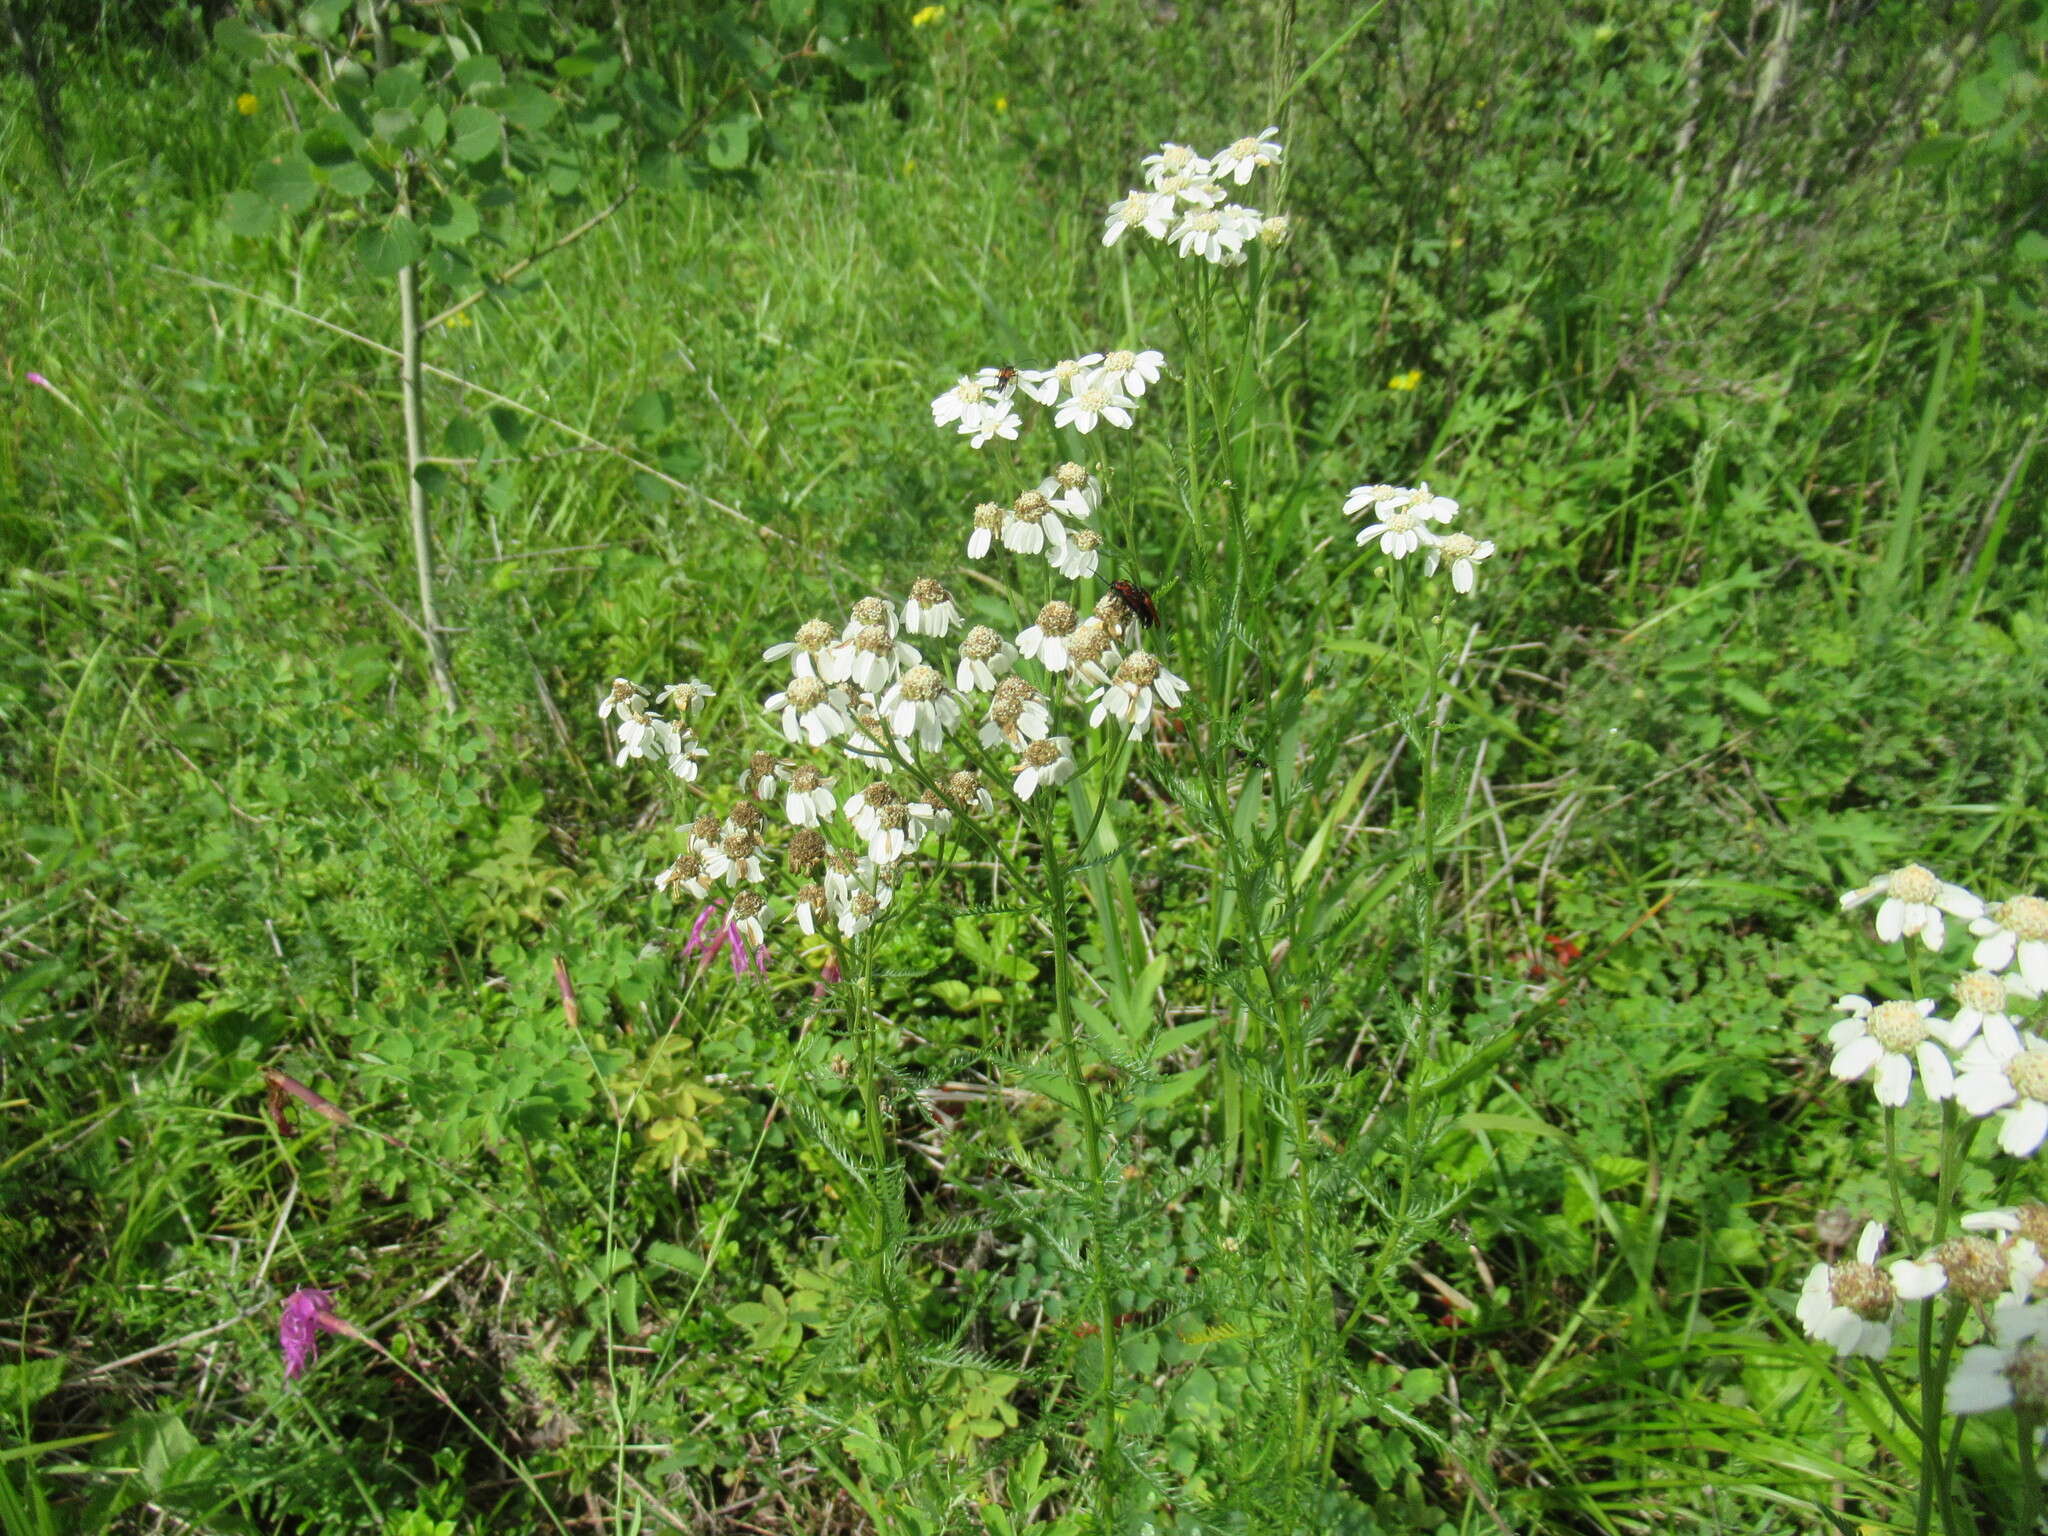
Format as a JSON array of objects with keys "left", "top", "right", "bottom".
[{"left": 1827, "top": 864, "right": 2048, "bottom": 1157}]
